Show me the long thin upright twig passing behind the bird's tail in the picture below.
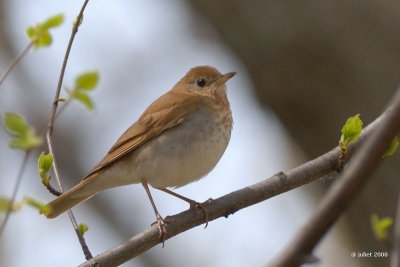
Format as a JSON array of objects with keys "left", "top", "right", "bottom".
[{"left": 46, "top": 0, "right": 92, "bottom": 259}]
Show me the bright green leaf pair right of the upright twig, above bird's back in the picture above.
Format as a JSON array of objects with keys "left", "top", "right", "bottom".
[{"left": 69, "top": 71, "right": 99, "bottom": 111}]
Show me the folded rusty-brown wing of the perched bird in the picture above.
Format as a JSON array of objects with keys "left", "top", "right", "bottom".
[{"left": 83, "top": 92, "right": 205, "bottom": 179}]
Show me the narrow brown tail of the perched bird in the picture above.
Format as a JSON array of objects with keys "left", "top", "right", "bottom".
[{"left": 45, "top": 179, "right": 96, "bottom": 219}]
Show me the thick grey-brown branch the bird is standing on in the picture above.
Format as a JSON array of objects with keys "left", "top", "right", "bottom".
[{"left": 80, "top": 103, "right": 390, "bottom": 267}]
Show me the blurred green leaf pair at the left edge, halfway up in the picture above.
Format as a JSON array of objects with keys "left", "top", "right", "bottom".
[{"left": 3, "top": 113, "right": 43, "bottom": 150}]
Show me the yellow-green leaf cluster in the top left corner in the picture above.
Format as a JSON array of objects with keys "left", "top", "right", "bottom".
[{"left": 26, "top": 14, "right": 64, "bottom": 48}]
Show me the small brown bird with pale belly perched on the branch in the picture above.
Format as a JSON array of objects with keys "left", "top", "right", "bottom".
[{"left": 45, "top": 66, "right": 236, "bottom": 240}]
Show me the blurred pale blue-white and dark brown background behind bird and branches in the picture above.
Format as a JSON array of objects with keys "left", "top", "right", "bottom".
[{"left": 0, "top": 0, "right": 400, "bottom": 267}]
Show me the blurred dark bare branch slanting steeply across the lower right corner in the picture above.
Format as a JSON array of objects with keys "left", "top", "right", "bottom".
[{"left": 269, "top": 88, "right": 400, "bottom": 267}]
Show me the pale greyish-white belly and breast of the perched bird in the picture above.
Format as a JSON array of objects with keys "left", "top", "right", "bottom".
[{"left": 101, "top": 106, "right": 231, "bottom": 188}]
